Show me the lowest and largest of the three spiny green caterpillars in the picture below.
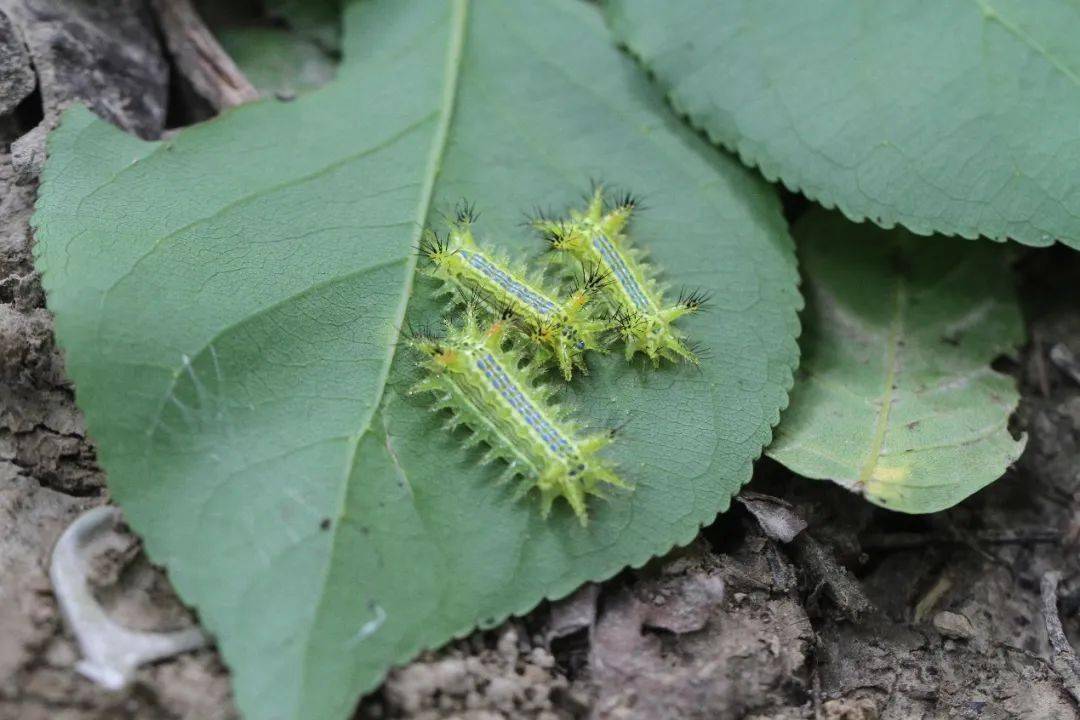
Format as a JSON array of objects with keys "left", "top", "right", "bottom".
[{"left": 409, "top": 304, "right": 625, "bottom": 525}]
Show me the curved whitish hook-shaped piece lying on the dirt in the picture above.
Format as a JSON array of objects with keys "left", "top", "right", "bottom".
[{"left": 49, "top": 505, "right": 207, "bottom": 690}]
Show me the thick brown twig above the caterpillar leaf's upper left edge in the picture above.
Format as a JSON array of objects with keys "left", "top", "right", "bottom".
[{"left": 150, "top": 0, "right": 259, "bottom": 110}]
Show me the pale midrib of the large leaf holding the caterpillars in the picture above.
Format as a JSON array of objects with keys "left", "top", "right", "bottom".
[{"left": 297, "top": 0, "right": 469, "bottom": 699}]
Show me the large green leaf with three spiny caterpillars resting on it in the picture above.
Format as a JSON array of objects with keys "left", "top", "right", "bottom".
[{"left": 35, "top": 0, "right": 801, "bottom": 720}]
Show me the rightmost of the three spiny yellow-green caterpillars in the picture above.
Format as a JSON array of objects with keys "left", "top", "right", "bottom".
[{"left": 534, "top": 186, "right": 708, "bottom": 366}]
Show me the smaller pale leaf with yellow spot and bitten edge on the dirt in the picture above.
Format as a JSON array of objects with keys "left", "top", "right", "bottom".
[{"left": 768, "top": 210, "right": 1024, "bottom": 513}]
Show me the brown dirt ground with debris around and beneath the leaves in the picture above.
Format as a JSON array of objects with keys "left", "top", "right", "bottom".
[{"left": 0, "top": 0, "right": 1080, "bottom": 720}]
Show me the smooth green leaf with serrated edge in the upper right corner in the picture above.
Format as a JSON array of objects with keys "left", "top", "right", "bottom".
[{"left": 609, "top": 0, "right": 1080, "bottom": 248}]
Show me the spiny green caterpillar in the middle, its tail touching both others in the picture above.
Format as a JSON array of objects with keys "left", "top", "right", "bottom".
[{"left": 419, "top": 203, "right": 608, "bottom": 381}]
